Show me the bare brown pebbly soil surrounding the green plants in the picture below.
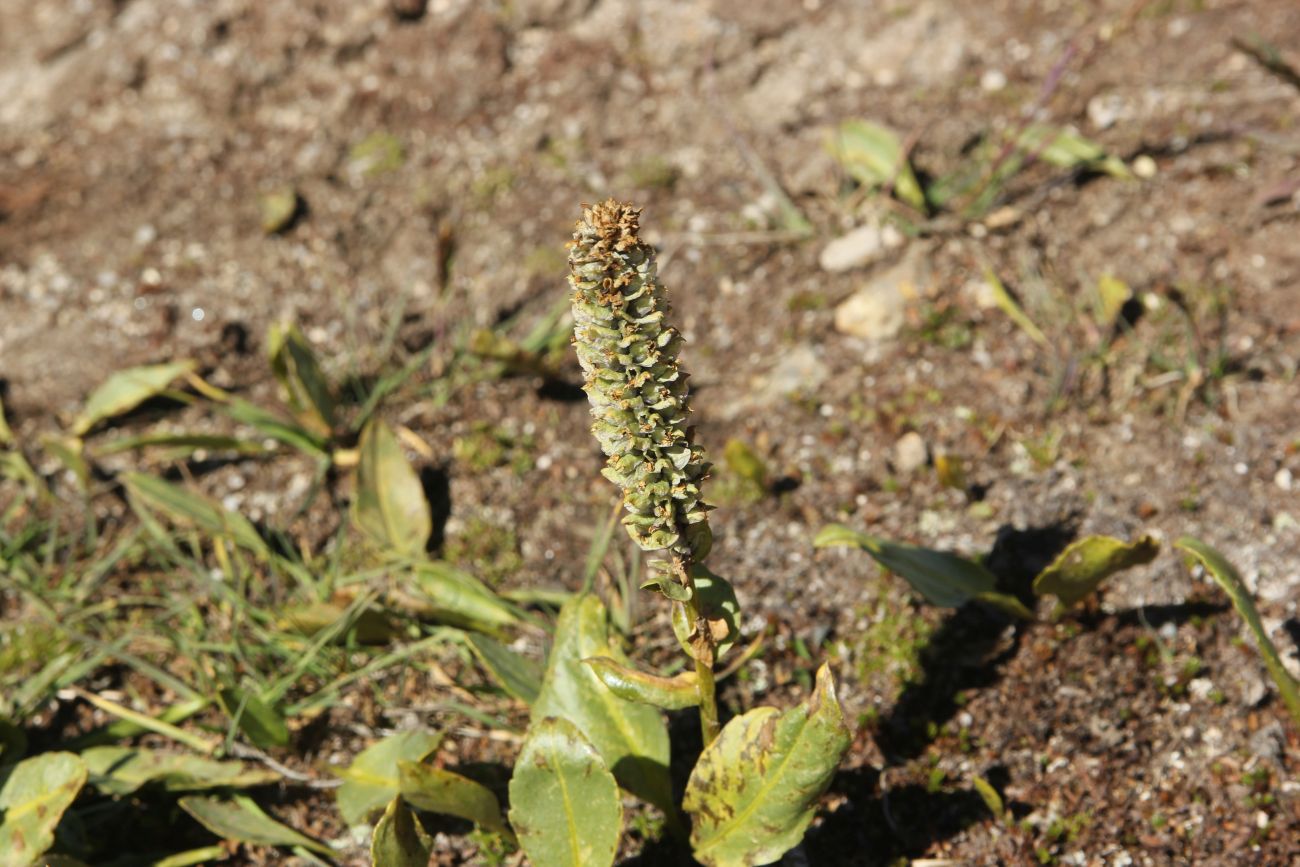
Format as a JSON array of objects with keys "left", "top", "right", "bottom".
[{"left": 0, "top": 0, "right": 1300, "bottom": 866}]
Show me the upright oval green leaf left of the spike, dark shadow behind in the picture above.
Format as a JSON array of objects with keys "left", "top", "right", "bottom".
[{"left": 352, "top": 419, "right": 433, "bottom": 556}]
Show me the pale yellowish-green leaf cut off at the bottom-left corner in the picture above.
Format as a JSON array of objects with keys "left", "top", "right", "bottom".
[{"left": 0, "top": 753, "right": 87, "bottom": 867}]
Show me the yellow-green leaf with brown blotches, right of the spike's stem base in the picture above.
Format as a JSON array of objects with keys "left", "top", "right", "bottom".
[{"left": 683, "top": 666, "right": 852, "bottom": 867}]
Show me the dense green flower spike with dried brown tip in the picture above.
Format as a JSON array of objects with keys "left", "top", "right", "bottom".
[{"left": 569, "top": 199, "right": 711, "bottom": 560}]
